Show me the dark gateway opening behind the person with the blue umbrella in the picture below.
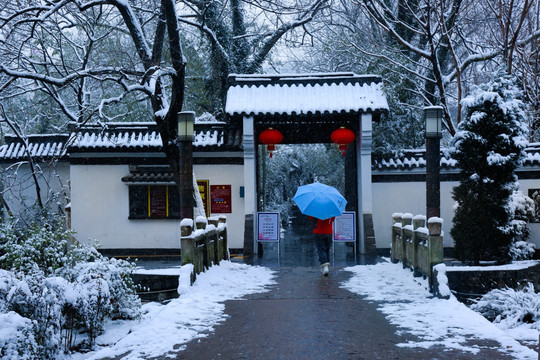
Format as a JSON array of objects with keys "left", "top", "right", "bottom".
[{"left": 257, "top": 143, "right": 358, "bottom": 266}]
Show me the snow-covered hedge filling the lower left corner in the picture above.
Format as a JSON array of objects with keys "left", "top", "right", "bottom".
[{"left": 0, "top": 219, "right": 141, "bottom": 359}]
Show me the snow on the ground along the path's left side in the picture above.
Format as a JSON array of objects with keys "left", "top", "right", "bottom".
[{"left": 68, "top": 261, "right": 275, "bottom": 360}]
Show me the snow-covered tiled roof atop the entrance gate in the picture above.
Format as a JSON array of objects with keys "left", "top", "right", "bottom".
[{"left": 225, "top": 73, "right": 388, "bottom": 115}]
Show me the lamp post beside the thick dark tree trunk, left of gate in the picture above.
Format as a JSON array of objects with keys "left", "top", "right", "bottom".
[{"left": 178, "top": 111, "right": 195, "bottom": 219}]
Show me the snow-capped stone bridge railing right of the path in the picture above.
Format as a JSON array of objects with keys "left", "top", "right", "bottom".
[{"left": 391, "top": 213, "right": 443, "bottom": 293}]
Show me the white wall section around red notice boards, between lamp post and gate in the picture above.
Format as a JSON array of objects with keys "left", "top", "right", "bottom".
[{"left": 193, "top": 165, "right": 245, "bottom": 249}]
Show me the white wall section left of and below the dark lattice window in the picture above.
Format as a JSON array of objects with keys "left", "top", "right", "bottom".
[{"left": 71, "top": 165, "right": 180, "bottom": 249}]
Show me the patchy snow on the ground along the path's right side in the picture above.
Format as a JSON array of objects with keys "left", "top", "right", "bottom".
[{"left": 342, "top": 262, "right": 538, "bottom": 360}]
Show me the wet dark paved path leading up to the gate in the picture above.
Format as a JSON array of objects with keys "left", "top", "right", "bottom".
[{"left": 171, "top": 228, "right": 510, "bottom": 360}]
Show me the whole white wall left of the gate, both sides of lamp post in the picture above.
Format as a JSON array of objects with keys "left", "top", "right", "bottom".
[{"left": 71, "top": 165, "right": 244, "bottom": 249}]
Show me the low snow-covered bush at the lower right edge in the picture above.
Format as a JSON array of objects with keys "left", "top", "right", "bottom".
[{"left": 471, "top": 283, "right": 540, "bottom": 330}]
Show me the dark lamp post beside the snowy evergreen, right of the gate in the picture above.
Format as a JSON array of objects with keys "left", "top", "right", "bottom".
[{"left": 424, "top": 106, "right": 443, "bottom": 219}]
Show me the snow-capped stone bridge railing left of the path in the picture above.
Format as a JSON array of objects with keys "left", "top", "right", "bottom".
[{"left": 180, "top": 216, "right": 229, "bottom": 284}]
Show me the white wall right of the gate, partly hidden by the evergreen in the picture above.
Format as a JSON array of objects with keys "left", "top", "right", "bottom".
[{"left": 373, "top": 176, "right": 540, "bottom": 249}]
